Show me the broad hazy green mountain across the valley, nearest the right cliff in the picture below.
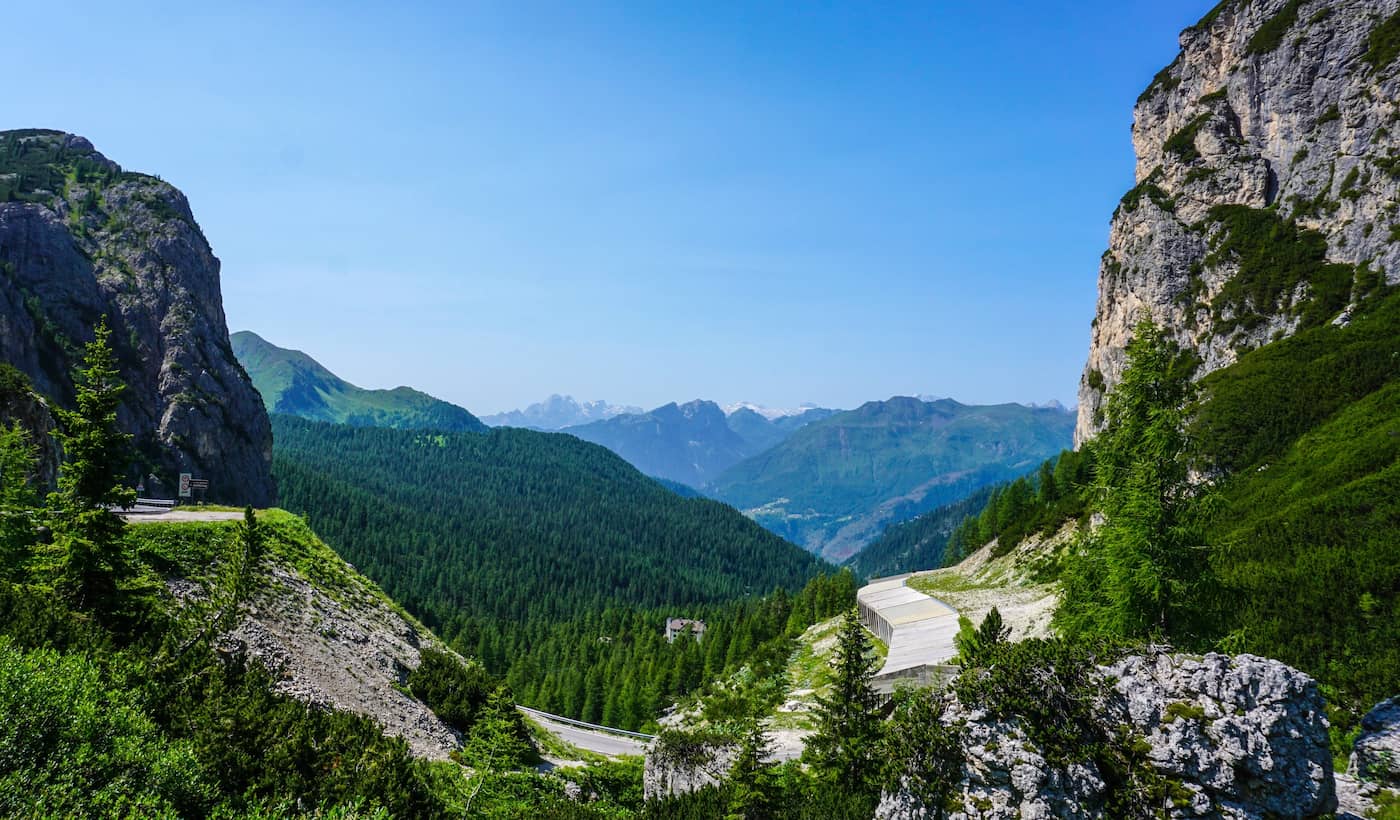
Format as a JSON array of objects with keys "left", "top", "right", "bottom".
[{"left": 708, "top": 397, "right": 1074, "bottom": 560}]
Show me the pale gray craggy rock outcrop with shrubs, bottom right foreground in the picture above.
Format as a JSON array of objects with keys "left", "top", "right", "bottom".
[{"left": 876, "top": 653, "right": 1337, "bottom": 820}]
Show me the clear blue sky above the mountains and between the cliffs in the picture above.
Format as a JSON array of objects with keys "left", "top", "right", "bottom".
[{"left": 0, "top": 0, "right": 1212, "bottom": 413}]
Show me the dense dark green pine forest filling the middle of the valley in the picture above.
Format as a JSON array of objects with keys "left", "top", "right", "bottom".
[{"left": 274, "top": 416, "right": 854, "bottom": 728}]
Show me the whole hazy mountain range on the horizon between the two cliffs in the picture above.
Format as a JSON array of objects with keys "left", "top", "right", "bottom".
[{"left": 231, "top": 330, "right": 1074, "bottom": 561}]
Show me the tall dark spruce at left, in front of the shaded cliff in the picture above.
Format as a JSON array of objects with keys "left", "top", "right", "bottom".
[{"left": 49, "top": 319, "right": 136, "bottom": 609}]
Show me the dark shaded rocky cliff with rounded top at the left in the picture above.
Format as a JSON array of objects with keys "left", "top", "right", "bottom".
[{"left": 0, "top": 130, "right": 276, "bottom": 505}]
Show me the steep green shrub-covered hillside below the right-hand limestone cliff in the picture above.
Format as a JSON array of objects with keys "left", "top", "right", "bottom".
[{"left": 1196, "top": 288, "right": 1400, "bottom": 709}]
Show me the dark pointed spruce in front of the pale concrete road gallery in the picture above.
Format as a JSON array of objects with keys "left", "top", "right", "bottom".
[{"left": 804, "top": 609, "right": 881, "bottom": 795}]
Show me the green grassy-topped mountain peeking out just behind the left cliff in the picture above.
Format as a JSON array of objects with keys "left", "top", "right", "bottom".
[{"left": 228, "top": 330, "right": 486, "bottom": 432}]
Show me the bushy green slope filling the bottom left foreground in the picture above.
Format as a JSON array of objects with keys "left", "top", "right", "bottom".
[{"left": 0, "top": 512, "right": 466, "bottom": 817}]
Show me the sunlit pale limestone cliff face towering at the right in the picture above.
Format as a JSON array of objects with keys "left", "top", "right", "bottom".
[{"left": 1075, "top": 0, "right": 1400, "bottom": 444}]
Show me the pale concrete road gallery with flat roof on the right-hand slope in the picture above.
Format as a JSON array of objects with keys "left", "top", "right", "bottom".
[{"left": 855, "top": 575, "right": 958, "bottom": 677}]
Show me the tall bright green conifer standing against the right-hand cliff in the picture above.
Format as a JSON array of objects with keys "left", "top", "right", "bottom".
[{"left": 1056, "top": 320, "right": 1208, "bottom": 639}]
